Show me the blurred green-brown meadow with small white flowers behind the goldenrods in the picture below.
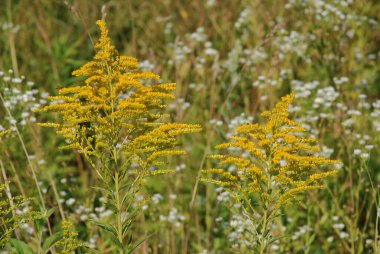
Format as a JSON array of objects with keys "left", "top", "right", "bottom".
[{"left": 0, "top": 0, "right": 380, "bottom": 253}]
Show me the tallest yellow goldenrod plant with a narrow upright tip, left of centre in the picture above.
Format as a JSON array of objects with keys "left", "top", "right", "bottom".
[{"left": 40, "top": 20, "right": 201, "bottom": 253}]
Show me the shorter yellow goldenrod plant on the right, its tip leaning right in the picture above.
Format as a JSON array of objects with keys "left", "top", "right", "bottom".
[{"left": 202, "top": 94, "right": 339, "bottom": 253}]
